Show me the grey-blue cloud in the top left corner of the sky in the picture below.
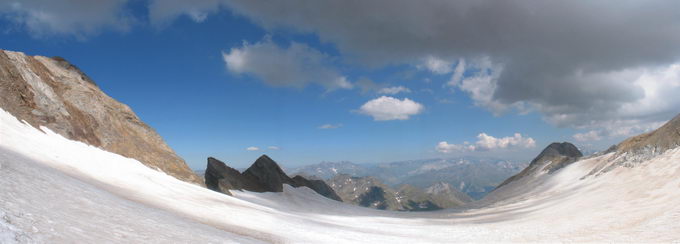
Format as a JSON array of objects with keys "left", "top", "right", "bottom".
[{"left": 0, "top": 0, "right": 135, "bottom": 37}]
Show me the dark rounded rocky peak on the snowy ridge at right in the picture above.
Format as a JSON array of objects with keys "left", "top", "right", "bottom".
[{"left": 496, "top": 142, "right": 583, "bottom": 189}]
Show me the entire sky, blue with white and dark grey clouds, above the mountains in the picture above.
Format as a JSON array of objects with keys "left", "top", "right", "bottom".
[{"left": 0, "top": 0, "right": 680, "bottom": 169}]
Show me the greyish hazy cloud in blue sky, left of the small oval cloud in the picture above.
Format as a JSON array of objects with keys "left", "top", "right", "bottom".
[{"left": 222, "top": 38, "right": 353, "bottom": 90}]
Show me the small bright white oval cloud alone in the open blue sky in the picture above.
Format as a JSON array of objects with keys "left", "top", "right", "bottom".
[{"left": 359, "top": 96, "right": 424, "bottom": 121}]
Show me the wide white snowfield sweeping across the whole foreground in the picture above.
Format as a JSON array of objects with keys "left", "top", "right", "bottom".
[{"left": 0, "top": 110, "right": 680, "bottom": 243}]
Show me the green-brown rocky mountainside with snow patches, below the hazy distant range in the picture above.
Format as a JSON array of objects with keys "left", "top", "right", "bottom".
[{"left": 329, "top": 174, "right": 471, "bottom": 211}]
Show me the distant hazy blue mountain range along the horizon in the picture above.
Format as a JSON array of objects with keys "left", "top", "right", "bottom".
[{"left": 288, "top": 157, "right": 528, "bottom": 199}]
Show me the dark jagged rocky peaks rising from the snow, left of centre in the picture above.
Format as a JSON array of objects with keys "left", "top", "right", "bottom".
[{"left": 205, "top": 155, "right": 342, "bottom": 201}]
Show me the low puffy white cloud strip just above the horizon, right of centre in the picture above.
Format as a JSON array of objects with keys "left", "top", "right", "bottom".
[{"left": 435, "top": 133, "right": 536, "bottom": 153}]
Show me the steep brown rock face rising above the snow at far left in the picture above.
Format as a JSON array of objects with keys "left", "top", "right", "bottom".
[{"left": 0, "top": 50, "right": 202, "bottom": 184}]
